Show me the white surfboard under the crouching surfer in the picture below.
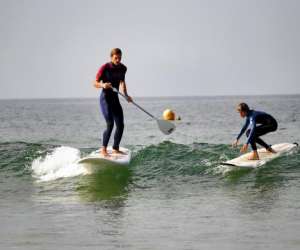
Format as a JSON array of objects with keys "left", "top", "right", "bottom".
[{"left": 221, "top": 143, "right": 298, "bottom": 168}]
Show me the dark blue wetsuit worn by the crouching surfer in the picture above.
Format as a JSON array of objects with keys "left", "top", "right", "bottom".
[{"left": 237, "top": 110, "right": 277, "bottom": 150}]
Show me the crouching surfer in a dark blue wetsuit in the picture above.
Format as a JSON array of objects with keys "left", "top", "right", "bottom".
[{"left": 232, "top": 103, "right": 277, "bottom": 160}]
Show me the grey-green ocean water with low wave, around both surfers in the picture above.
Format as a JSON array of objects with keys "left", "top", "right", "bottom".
[{"left": 0, "top": 95, "right": 300, "bottom": 250}]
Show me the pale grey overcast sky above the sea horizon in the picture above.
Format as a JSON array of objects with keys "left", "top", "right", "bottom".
[{"left": 0, "top": 0, "right": 300, "bottom": 98}]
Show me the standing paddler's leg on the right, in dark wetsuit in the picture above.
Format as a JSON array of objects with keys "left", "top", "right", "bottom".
[{"left": 113, "top": 104, "right": 124, "bottom": 153}]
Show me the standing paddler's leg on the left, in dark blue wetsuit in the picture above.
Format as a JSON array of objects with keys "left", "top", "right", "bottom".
[{"left": 100, "top": 99, "right": 114, "bottom": 156}]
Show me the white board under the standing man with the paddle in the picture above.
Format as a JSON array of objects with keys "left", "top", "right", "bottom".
[{"left": 77, "top": 147, "right": 131, "bottom": 172}]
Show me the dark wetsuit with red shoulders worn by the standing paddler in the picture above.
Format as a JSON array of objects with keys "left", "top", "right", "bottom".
[{"left": 96, "top": 63, "right": 127, "bottom": 150}]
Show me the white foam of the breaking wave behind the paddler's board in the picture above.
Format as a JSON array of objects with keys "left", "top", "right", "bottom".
[{"left": 31, "top": 146, "right": 87, "bottom": 181}]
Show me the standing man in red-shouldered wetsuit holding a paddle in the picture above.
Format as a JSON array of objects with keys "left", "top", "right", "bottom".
[{"left": 93, "top": 48, "right": 132, "bottom": 156}]
